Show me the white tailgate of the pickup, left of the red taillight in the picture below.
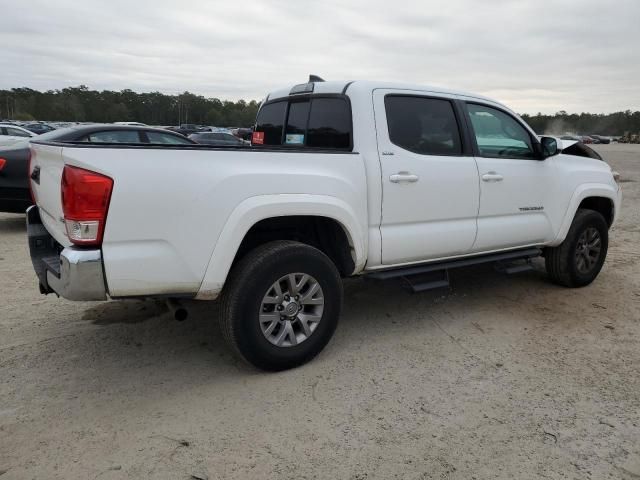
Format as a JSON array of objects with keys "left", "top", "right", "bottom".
[{"left": 29, "top": 144, "right": 71, "bottom": 247}]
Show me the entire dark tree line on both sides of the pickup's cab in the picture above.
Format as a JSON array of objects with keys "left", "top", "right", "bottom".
[{"left": 0, "top": 85, "right": 640, "bottom": 135}]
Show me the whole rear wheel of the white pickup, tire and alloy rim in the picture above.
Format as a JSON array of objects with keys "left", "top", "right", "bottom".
[{"left": 220, "top": 241, "right": 342, "bottom": 370}]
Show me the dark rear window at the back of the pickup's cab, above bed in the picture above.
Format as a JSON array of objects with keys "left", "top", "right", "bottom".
[{"left": 255, "top": 97, "right": 352, "bottom": 150}]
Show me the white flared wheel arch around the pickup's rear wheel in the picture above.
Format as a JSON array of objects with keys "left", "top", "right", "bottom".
[{"left": 196, "top": 194, "right": 366, "bottom": 300}]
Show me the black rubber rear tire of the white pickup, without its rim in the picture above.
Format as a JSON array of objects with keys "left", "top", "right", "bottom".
[{"left": 220, "top": 241, "right": 342, "bottom": 371}]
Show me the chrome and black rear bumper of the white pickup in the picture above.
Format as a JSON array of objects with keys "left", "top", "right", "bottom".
[{"left": 27, "top": 205, "right": 107, "bottom": 301}]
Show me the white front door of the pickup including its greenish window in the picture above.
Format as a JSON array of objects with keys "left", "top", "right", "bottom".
[{"left": 465, "top": 102, "right": 554, "bottom": 252}]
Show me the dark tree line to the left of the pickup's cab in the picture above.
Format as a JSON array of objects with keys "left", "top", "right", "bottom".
[{"left": 0, "top": 85, "right": 259, "bottom": 127}]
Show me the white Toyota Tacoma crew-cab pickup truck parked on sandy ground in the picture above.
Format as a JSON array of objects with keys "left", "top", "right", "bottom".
[{"left": 27, "top": 78, "right": 621, "bottom": 370}]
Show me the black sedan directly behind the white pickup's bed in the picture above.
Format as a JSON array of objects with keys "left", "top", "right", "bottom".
[{"left": 0, "top": 125, "right": 196, "bottom": 213}]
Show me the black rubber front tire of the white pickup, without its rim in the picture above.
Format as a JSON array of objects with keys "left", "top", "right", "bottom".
[{"left": 545, "top": 209, "right": 609, "bottom": 288}]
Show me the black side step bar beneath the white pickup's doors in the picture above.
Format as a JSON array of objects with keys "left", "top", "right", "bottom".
[{"left": 366, "top": 248, "right": 542, "bottom": 292}]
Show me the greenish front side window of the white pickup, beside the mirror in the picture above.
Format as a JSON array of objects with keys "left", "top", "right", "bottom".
[{"left": 467, "top": 103, "right": 536, "bottom": 158}]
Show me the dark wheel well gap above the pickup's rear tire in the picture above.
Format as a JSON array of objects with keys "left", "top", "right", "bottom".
[{"left": 233, "top": 215, "right": 355, "bottom": 276}]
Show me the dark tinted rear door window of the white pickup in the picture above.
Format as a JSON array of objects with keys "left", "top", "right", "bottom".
[{"left": 384, "top": 95, "right": 462, "bottom": 155}]
